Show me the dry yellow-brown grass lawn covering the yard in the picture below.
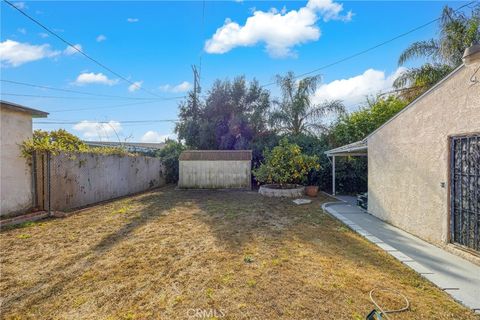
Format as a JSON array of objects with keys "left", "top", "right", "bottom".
[{"left": 0, "top": 187, "right": 478, "bottom": 319}]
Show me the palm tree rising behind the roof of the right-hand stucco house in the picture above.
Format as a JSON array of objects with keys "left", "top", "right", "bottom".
[{"left": 393, "top": 5, "right": 480, "bottom": 99}]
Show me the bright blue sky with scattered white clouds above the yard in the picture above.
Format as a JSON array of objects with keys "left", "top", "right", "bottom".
[{"left": 0, "top": 0, "right": 466, "bottom": 142}]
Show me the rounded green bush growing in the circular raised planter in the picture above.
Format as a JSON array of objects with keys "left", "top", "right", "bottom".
[{"left": 253, "top": 139, "right": 320, "bottom": 185}]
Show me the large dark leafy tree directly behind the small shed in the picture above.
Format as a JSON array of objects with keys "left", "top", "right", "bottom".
[{"left": 175, "top": 76, "right": 270, "bottom": 150}]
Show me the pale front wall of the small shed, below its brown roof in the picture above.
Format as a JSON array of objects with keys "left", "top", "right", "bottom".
[{"left": 178, "top": 160, "right": 251, "bottom": 189}]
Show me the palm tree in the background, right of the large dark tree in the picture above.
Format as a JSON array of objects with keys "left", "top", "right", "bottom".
[{"left": 270, "top": 72, "right": 345, "bottom": 135}]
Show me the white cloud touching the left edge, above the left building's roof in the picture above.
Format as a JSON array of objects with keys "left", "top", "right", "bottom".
[{"left": 0, "top": 39, "right": 60, "bottom": 67}]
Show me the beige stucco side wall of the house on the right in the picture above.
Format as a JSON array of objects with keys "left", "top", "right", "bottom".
[{"left": 368, "top": 63, "right": 480, "bottom": 244}]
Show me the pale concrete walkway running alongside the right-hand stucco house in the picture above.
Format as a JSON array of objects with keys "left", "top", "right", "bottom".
[{"left": 323, "top": 199, "right": 480, "bottom": 313}]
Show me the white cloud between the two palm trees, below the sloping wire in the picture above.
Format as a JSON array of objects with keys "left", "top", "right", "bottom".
[{"left": 312, "top": 67, "right": 405, "bottom": 107}]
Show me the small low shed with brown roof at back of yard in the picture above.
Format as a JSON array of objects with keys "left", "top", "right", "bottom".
[{"left": 178, "top": 150, "right": 252, "bottom": 189}]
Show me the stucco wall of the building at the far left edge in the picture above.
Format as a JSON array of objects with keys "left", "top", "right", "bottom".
[{"left": 0, "top": 107, "right": 32, "bottom": 216}]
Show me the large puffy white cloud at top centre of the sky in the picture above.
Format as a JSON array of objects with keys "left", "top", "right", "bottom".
[{"left": 204, "top": 0, "right": 353, "bottom": 57}]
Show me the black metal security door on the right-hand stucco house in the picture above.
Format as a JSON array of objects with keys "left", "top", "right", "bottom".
[{"left": 450, "top": 134, "right": 480, "bottom": 251}]
